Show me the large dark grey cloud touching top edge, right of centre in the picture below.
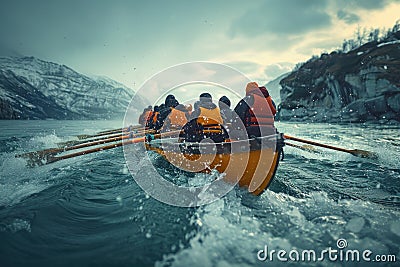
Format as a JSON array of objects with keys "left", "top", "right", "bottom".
[{"left": 229, "top": 0, "right": 331, "bottom": 38}]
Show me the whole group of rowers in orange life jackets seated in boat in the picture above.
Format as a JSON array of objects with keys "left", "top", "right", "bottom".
[{"left": 139, "top": 82, "right": 276, "bottom": 143}]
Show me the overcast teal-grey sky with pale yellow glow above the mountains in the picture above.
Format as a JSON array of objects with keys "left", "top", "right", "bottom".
[{"left": 0, "top": 0, "right": 400, "bottom": 93}]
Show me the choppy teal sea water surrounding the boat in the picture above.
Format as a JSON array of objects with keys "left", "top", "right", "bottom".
[{"left": 0, "top": 121, "right": 400, "bottom": 266}]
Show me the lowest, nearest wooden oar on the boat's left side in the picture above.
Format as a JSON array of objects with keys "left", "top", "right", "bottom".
[{"left": 29, "top": 130, "right": 181, "bottom": 166}]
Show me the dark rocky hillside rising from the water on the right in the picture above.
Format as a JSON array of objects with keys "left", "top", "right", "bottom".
[{"left": 278, "top": 31, "right": 400, "bottom": 122}]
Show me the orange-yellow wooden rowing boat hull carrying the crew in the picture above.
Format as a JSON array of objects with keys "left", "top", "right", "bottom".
[{"left": 145, "top": 134, "right": 283, "bottom": 195}]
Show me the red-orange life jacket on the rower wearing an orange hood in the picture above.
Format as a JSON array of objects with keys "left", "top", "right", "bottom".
[{"left": 246, "top": 94, "right": 276, "bottom": 127}]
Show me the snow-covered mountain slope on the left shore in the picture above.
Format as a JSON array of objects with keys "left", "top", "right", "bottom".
[{"left": 0, "top": 57, "right": 146, "bottom": 119}]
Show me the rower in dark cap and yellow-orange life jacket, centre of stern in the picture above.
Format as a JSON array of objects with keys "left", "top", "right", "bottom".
[{"left": 181, "top": 93, "right": 227, "bottom": 143}]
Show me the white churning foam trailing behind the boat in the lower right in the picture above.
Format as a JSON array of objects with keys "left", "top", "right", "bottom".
[{"left": 156, "top": 191, "right": 400, "bottom": 266}]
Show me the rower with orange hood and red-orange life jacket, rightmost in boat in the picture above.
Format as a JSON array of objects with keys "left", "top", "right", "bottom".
[{"left": 234, "top": 82, "right": 276, "bottom": 138}]
